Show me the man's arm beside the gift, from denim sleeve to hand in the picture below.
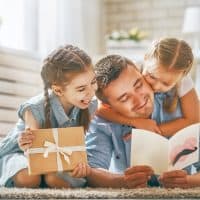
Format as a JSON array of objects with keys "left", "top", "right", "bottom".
[{"left": 86, "top": 117, "right": 152, "bottom": 188}]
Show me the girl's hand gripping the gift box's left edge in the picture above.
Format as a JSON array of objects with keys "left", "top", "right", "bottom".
[{"left": 18, "top": 128, "right": 34, "bottom": 151}]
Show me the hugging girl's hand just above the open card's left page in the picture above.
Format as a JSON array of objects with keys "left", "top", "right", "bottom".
[{"left": 134, "top": 118, "right": 162, "bottom": 135}]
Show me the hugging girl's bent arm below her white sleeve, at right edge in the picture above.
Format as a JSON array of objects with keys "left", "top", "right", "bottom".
[{"left": 159, "top": 88, "right": 200, "bottom": 137}]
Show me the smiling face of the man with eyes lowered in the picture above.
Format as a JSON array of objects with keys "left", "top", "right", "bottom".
[{"left": 103, "top": 65, "right": 154, "bottom": 118}]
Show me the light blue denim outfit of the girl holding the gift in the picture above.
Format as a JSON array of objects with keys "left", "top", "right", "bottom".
[{"left": 0, "top": 93, "right": 97, "bottom": 187}]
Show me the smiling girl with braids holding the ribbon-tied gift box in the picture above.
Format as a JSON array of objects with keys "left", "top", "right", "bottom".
[{"left": 0, "top": 45, "right": 97, "bottom": 188}]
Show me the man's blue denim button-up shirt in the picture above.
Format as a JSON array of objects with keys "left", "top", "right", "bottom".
[{"left": 86, "top": 93, "right": 192, "bottom": 176}]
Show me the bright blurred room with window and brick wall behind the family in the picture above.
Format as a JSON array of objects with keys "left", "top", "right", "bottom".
[{"left": 0, "top": 0, "right": 200, "bottom": 137}]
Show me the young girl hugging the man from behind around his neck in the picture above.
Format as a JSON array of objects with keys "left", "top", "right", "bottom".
[{"left": 97, "top": 38, "right": 200, "bottom": 137}]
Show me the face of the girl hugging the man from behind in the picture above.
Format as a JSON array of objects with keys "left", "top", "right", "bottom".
[{"left": 143, "top": 61, "right": 184, "bottom": 92}]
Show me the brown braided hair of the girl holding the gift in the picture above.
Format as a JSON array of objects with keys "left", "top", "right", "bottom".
[{"left": 41, "top": 45, "right": 92, "bottom": 130}]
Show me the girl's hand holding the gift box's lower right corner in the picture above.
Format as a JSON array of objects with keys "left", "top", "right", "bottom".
[{"left": 71, "top": 163, "right": 91, "bottom": 178}]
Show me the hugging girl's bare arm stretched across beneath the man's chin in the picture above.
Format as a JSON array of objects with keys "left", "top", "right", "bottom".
[{"left": 96, "top": 104, "right": 161, "bottom": 134}]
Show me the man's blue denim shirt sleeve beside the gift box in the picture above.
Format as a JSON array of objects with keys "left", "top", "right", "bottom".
[{"left": 86, "top": 117, "right": 113, "bottom": 169}]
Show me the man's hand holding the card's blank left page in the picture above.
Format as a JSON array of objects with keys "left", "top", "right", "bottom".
[{"left": 124, "top": 165, "right": 153, "bottom": 188}]
